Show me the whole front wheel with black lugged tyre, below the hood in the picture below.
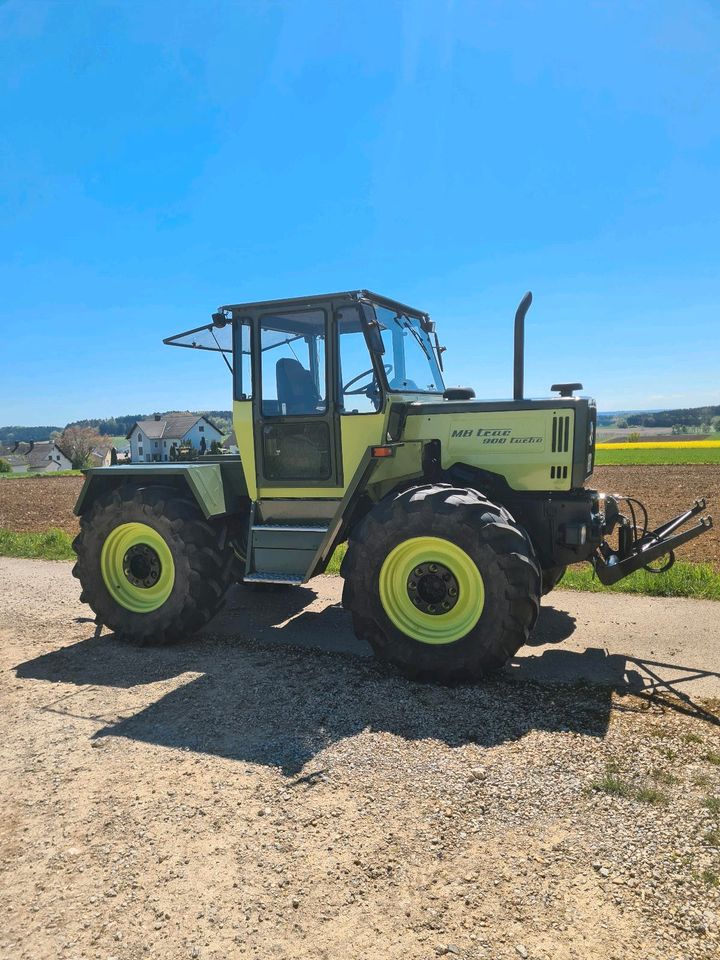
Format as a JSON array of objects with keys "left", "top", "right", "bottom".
[{"left": 340, "top": 484, "right": 541, "bottom": 683}]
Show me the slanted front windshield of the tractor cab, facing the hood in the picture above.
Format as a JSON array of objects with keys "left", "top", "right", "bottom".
[{"left": 375, "top": 307, "right": 445, "bottom": 393}]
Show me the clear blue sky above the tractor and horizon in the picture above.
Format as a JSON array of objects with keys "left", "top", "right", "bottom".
[{"left": 0, "top": 0, "right": 720, "bottom": 424}]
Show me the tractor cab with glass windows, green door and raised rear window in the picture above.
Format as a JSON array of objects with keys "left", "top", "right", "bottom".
[{"left": 164, "top": 291, "right": 445, "bottom": 500}]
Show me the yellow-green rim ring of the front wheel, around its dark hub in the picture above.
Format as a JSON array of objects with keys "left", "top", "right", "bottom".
[{"left": 379, "top": 537, "right": 485, "bottom": 644}]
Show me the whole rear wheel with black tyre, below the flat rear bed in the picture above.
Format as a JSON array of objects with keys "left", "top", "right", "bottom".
[{"left": 73, "top": 485, "right": 235, "bottom": 645}]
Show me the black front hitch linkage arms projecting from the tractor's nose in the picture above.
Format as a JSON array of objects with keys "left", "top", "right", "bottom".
[{"left": 593, "top": 497, "right": 713, "bottom": 585}]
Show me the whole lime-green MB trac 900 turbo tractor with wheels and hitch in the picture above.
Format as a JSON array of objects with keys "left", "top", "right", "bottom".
[{"left": 73, "top": 290, "right": 712, "bottom": 682}]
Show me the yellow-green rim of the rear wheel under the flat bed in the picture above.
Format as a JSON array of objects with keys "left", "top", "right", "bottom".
[{"left": 100, "top": 523, "right": 175, "bottom": 613}]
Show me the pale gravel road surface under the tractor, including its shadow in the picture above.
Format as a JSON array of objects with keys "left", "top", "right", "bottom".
[{"left": 0, "top": 559, "right": 720, "bottom": 960}]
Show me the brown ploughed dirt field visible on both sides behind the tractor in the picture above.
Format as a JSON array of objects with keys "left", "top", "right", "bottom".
[{"left": 0, "top": 465, "right": 720, "bottom": 570}]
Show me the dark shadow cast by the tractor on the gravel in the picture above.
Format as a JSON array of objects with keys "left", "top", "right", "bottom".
[{"left": 16, "top": 588, "right": 717, "bottom": 776}]
